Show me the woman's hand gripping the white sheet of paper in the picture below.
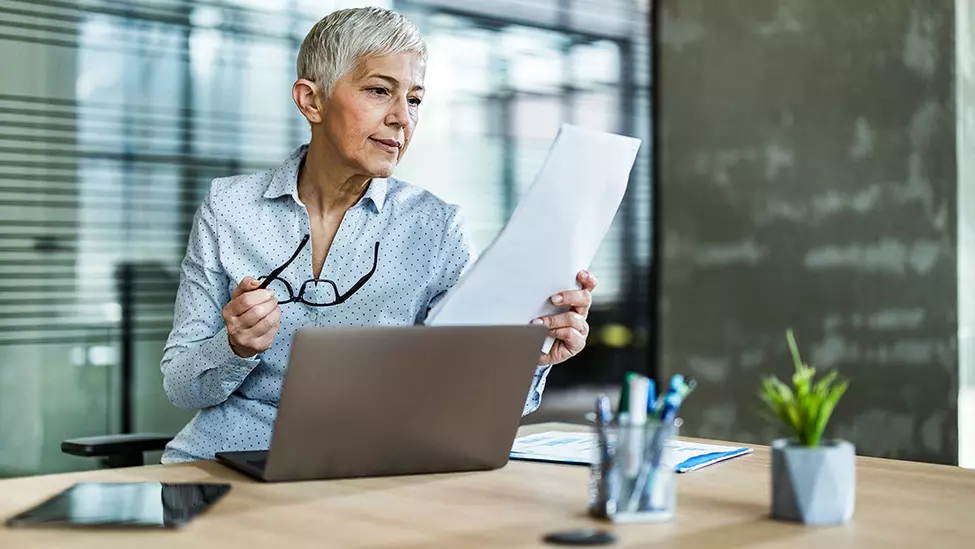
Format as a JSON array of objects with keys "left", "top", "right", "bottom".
[{"left": 532, "top": 271, "right": 598, "bottom": 365}]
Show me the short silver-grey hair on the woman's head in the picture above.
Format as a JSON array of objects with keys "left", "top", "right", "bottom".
[{"left": 298, "top": 7, "right": 427, "bottom": 94}]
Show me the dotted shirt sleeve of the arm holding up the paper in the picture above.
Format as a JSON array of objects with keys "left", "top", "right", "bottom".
[{"left": 426, "top": 207, "right": 552, "bottom": 416}]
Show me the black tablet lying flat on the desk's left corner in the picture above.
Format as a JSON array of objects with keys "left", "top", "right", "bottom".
[{"left": 7, "top": 482, "right": 230, "bottom": 528}]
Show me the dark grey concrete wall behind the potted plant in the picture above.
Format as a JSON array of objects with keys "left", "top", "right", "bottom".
[{"left": 658, "top": 0, "right": 958, "bottom": 463}]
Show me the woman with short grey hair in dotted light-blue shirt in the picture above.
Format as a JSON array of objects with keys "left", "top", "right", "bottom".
[{"left": 162, "top": 8, "right": 596, "bottom": 463}]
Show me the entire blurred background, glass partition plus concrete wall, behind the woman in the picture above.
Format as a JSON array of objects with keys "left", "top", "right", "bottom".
[{"left": 0, "top": 0, "right": 975, "bottom": 475}]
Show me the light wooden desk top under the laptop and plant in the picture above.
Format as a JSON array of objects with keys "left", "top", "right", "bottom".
[{"left": 0, "top": 424, "right": 975, "bottom": 549}]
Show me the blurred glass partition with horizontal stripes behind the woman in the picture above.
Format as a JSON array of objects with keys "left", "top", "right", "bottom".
[{"left": 0, "top": 0, "right": 652, "bottom": 475}]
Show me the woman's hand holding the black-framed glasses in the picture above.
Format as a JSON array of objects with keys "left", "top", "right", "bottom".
[{"left": 222, "top": 276, "right": 281, "bottom": 358}]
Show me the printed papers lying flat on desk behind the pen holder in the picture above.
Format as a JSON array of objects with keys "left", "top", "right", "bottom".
[{"left": 511, "top": 431, "right": 752, "bottom": 473}]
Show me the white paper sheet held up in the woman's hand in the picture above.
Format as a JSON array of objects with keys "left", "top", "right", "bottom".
[{"left": 426, "top": 124, "right": 641, "bottom": 352}]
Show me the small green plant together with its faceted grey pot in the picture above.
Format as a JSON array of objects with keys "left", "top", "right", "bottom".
[{"left": 760, "top": 329, "right": 856, "bottom": 525}]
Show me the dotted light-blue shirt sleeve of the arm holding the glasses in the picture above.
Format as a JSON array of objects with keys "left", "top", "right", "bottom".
[{"left": 160, "top": 183, "right": 260, "bottom": 410}]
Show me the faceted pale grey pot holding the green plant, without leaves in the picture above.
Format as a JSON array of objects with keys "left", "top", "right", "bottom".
[{"left": 772, "top": 439, "right": 856, "bottom": 525}]
